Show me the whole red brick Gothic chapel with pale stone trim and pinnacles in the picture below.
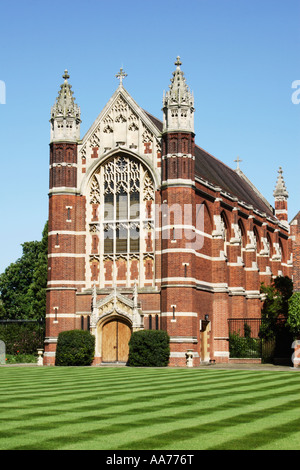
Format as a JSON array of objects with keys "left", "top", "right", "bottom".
[{"left": 44, "top": 57, "right": 292, "bottom": 366}]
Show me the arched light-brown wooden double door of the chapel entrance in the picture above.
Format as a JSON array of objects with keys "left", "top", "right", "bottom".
[{"left": 102, "top": 318, "right": 131, "bottom": 362}]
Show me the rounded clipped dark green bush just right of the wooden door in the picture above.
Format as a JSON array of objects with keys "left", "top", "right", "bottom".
[{"left": 128, "top": 330, "right": 170, "bottom": 367}]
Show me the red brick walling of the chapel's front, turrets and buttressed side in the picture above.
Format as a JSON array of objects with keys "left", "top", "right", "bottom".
[{"left": 45, "top": 137, "right": 292, "bottom": 365}]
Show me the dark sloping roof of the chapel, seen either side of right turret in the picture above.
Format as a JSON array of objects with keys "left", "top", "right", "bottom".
[{"left": 145, "top": 111, "right": 274, "bottom": 217}]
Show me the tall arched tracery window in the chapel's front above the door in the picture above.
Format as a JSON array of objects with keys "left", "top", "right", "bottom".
[{"left": 88, "top": 153, "right": 154, "bottom": 287}]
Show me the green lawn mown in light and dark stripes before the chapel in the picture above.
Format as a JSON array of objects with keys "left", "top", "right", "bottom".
[{"left": 0, "top": 367, "right": 300, "bottom": 450}]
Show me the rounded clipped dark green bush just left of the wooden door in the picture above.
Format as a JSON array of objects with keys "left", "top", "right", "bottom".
[{"left": 55, "top": 330, "right": 95, "bottom": 366}]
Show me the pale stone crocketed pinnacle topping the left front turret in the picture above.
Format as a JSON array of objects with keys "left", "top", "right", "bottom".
[{"left": 51, "top": 70, "right": 80, "bottom": 122}]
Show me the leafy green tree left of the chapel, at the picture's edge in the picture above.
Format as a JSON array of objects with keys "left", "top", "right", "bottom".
[{"left": 0, "top": 222, "right": 48, "bottom": 319}]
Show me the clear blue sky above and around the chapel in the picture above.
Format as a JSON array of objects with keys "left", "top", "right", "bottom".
[{"left": 0, "top": 0, "right": 300, "bottom": 272}]
